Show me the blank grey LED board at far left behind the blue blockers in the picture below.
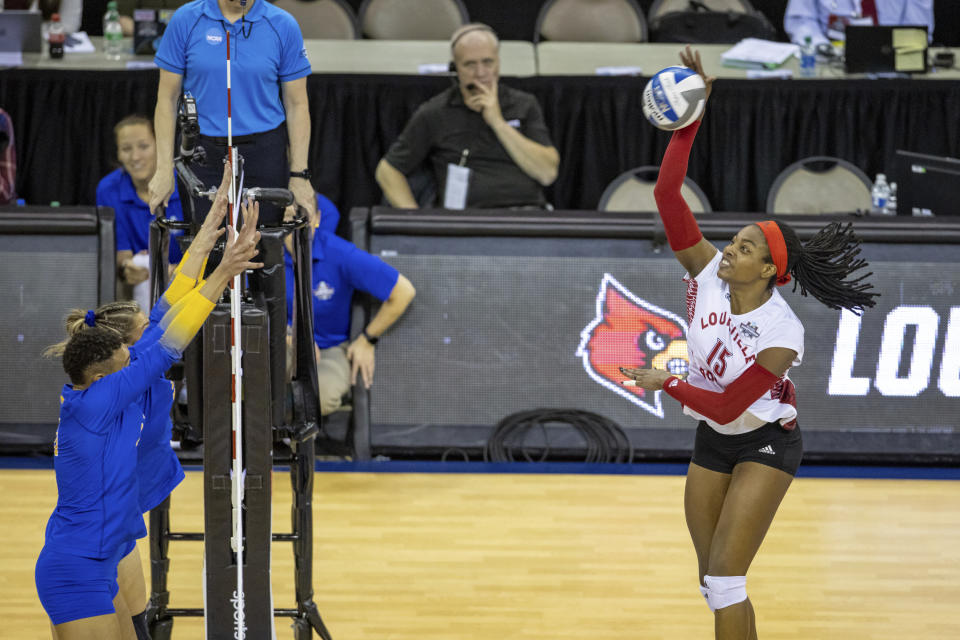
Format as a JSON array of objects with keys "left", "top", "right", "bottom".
[{"left": 0, "top": 207, "right": 116, "bottom": 453}]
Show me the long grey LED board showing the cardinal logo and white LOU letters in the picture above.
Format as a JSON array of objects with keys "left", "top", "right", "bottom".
[{"left": 358, "top": 208, "right": 960, "bottom": 464}]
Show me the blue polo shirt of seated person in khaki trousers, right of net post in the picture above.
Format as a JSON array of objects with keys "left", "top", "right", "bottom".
[{"left": 284, "top": 230, "right": 400, "bottom": 349}]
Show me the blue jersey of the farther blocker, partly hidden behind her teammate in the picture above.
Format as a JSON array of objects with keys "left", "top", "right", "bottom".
[{"left": 130, "top": 312, "right": 184, "bottom": 513}]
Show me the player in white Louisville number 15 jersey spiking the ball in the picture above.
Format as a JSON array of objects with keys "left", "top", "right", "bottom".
[{"left": 621, "top": 47, "right": 878, "bottom": 640}]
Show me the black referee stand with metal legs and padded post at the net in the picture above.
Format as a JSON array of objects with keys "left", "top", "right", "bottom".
[{"left": 147, "top": 215, "right": 332, "bottom": 640}]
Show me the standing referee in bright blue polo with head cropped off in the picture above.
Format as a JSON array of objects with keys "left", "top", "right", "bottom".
[{"left": 149, "top": 0, "right": 317, "bottom": 225}]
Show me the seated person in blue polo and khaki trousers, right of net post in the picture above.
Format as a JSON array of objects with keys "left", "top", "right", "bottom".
[{"left": 284, "top": 202, "right": 417, "bottom": 415}]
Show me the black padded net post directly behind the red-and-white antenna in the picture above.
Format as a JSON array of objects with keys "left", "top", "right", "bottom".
[{"left": 203, "top": 303, "right": 273, "bottom": 640}]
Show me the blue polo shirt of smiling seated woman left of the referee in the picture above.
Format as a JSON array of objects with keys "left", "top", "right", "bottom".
[{"left": 97, "top": 169, "right": 183, "bottom": 264}]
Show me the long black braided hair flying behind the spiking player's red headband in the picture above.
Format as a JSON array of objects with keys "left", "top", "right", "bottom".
[{"left": 767, "top": 221, "right": 880, "bottom": 315}]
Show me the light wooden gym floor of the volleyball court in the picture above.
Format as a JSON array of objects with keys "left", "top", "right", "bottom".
[{"left": 0, "top": 469, "right": 960, "bottom": 640}]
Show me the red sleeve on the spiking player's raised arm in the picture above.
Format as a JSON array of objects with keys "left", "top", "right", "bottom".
[{"left": 653, "top": 121, "right": 703, "bottom": 251}]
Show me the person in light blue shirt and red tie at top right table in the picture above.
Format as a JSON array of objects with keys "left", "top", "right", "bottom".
[{"left": 783, "top": 0, "right": 933, "bottom": 46}]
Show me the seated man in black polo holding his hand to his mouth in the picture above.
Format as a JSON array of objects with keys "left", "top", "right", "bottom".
[{"left": 376, "top": 24, "right": 560, "bottom": 209}]
